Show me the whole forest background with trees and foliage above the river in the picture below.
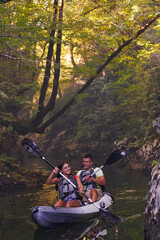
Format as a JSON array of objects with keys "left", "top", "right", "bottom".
[{"left": 0, "top": 0, "right": 160, "bottom": 172}]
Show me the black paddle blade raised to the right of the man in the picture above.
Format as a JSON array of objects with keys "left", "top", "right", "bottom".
[{"left": 104, "top": 147, "right": 126, "bottom": 166}]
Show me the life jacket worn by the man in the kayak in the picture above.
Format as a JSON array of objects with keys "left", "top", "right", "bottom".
[{"left": 79, "top": 168, "right": 98, "bottom": 192}]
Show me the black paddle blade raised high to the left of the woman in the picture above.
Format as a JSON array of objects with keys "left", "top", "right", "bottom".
[{"left": 21, "top": 138, "right": 42, "bottom": 157}]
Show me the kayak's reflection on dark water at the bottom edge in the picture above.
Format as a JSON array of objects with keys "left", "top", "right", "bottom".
[{"left": 33, "top": 218, "right": 115, "bottom": 240}]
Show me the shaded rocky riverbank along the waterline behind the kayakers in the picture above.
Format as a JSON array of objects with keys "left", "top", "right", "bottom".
[{"left": 0, "top": 132, "right": 160, "bottom": 194}]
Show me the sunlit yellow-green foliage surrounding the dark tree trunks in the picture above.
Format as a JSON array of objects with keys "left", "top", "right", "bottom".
[{"left": 0, "top": 0, "right": 160, "bottom": 139}]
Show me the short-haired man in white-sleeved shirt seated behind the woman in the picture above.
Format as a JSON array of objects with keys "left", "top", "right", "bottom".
[{"left": 77, "top": 154, "right": 105, "bottom": 202}]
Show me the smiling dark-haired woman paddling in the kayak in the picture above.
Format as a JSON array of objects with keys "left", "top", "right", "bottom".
[{"left": 46, "top": 163, "right": 83, "bottom": 207}]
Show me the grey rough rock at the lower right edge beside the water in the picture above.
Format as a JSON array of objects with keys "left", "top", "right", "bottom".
[{"left": 144, "top": 164, "right": 160, "bottom": 240}]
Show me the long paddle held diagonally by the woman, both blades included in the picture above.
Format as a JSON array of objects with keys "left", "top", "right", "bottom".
[{"left": 22, "top": 138, "right": 121, "bottom": 222}]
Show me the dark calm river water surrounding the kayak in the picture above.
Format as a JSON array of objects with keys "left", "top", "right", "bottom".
[{"left": 0, "top": 158, "right": 149, "bottom": 240}]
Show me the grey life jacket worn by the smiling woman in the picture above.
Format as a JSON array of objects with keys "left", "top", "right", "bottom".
[{"left": 58, "top": 175, "right": 81, "bottom": 201}]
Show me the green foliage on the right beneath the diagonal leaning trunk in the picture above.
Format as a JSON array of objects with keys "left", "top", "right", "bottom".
[{"left": 55, "top": 26, "right": 160, "bottom": 147}]
